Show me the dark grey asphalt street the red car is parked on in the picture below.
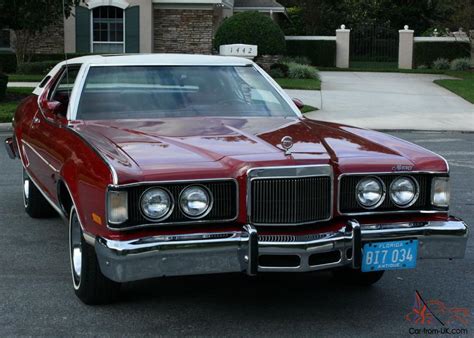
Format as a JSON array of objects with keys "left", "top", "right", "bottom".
[{"left": 0, "top": 132, "right": 474, "bottom": 337}]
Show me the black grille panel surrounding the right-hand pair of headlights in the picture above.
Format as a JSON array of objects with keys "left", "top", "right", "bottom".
[{"left": 339, "top": 174, "right": 433, "bottom": 213}]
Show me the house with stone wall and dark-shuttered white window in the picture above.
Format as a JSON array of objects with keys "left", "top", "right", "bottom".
[{"left": 0, "top": 0, "right": 286, "bottom": 54}]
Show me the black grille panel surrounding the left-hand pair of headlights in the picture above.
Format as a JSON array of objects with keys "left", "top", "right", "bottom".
[{"left": 111, "top": 180, "right": 237, "bottom": 228}]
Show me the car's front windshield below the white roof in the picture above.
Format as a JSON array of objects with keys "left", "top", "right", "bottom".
[{"left": 76, "top": 66, "right": 295, "bottom": 120}]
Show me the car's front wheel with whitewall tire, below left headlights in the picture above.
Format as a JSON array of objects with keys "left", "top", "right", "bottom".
[{"left": 69, "top": 207, "right": 120, "bottom": 305}]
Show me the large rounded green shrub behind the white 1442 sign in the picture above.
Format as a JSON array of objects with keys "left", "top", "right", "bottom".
[{"left": 214, "top": 12, "right": 286, "bottom": 55}]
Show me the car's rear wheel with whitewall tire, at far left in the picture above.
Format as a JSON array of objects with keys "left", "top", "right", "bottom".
[{"left": 23, "top": 169, "right": 57, "bottom": 218}]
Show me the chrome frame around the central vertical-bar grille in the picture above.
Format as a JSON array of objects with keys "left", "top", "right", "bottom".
[{"left": 246, "top": 164, "right": 334, "bottom": 227}]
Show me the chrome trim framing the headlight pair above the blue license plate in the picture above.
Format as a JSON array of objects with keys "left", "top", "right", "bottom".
[{"left": 337, "top": 170, "right": 449, "bottom": 216}]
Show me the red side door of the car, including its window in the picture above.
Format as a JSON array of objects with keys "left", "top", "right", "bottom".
[{"left": 24, "top": 65, "right": 80, "bottom": 202}]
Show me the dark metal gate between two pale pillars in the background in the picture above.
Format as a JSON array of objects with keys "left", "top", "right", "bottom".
[{"left": 350, "top": 25, "right": 399, "bottom": 68}]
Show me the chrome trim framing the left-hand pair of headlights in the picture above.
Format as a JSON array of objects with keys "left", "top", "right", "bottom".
[{"left": 105, "top": 177, "right": 240, "bottom": 231}]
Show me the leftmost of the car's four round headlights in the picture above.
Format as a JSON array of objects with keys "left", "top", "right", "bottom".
[{"left": 140, "top": 188, "right": 173, "bottom": 221}]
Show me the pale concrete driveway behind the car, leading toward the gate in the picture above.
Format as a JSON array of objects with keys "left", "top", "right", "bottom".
[{"left": 287, "top": 72, "right": 474, "bottom": 131}]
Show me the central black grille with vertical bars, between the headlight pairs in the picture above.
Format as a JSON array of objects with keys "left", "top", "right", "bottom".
[{"left": 250, "top": 176, "right": 331, "bottom": 225}]
